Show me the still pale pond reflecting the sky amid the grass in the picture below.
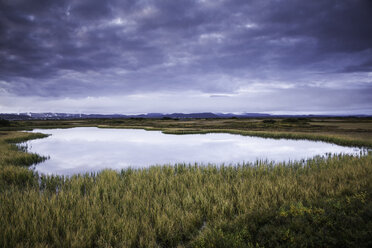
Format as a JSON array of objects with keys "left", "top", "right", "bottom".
[{"left": 26, "top": 127, "right": 360, "bottom": 175}]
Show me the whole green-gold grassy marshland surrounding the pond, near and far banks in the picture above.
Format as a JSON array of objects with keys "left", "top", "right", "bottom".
[{"left": 0, "top": 118, "right": 372, "bottom": 247}]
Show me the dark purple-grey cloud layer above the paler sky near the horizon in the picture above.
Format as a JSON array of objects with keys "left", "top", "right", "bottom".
[{"left": 0, "top": 0, "right": 372, "bottom": 112}]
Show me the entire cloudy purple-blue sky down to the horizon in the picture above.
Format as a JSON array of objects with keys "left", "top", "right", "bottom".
[{"left": 0, "top": 0, "right": 372, "bottom": 114}]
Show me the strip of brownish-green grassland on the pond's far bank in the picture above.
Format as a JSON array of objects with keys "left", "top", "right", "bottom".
[{"left": 5, "top": 118, "right": 372, "bottom": 148}]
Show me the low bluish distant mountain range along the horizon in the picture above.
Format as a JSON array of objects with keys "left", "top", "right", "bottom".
[{"left": 0, "top": 112, "right": 371, "bottom": 120}]
